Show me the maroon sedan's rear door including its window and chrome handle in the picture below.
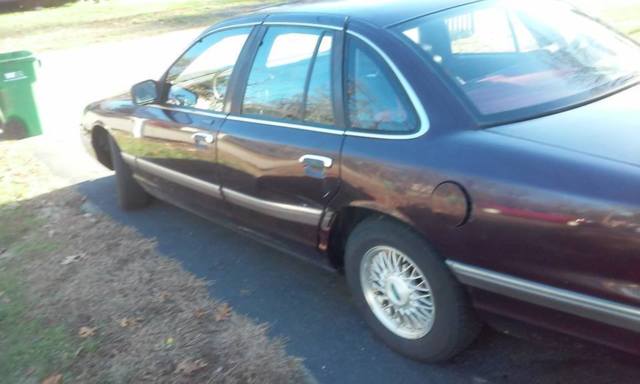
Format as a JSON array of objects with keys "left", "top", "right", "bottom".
[{"left": 218, "top": 22, "right": 344, "bottom": 247}]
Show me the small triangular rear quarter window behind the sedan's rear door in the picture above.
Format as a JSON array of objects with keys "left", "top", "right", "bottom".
[{"left": 346, "top": 37, "right": 418, "bottom": 133}]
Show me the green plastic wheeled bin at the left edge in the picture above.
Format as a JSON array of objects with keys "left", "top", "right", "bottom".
[{"left": 0, "top": 51, "right": 42, "bottom": 140}]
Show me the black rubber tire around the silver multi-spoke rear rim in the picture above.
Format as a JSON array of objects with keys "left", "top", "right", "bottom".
[{"left": 345, "top": 218, "right": 481, "bottom": 362}]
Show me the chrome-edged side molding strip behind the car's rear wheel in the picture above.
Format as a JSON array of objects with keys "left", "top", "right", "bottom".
[{"left": 447, "top": 260, "right": 640, "bottom": 332}]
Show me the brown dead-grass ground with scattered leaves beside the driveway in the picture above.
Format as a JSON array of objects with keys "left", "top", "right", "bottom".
[{"left": 0, "top": 143, "right": 309, "bottom": 383}]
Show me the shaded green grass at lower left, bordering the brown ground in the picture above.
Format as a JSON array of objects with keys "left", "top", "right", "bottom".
[{"left": 0, "top": 207, "right": 87, "bottom": 383}]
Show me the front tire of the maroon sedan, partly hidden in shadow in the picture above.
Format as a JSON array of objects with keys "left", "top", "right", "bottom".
[{"left": 109, "top": 136, "right": 151, "bottom": 211}]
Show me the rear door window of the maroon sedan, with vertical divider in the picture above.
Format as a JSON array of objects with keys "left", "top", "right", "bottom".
[{"left": 242, "top": 27, "right": 334, "bottom": 125}]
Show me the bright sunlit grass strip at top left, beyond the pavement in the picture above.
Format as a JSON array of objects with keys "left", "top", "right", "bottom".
[{"left": 0, "top": 0, "right": 275, "bottom": 51}]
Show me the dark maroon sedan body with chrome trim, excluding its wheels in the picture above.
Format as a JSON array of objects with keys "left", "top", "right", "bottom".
[{"left": 82, "top": 0, "right": 640, "bottom": 360}]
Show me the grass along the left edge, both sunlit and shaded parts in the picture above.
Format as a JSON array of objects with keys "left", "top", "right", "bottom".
[{"left": 0, "top": 144, "right": 84, "bottom": 383}]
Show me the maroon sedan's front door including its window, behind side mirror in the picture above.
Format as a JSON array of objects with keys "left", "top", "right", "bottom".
[{"left": 120, "top": 27, "right": 252, "bottom": 216}]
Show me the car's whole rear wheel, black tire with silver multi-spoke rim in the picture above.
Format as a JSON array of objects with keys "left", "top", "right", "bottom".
[{"left": 345, "top": 219, "right": 480, "bottom": 362}]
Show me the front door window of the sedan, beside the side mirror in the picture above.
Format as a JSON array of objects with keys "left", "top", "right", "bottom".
[{"left": 167, "top": 28, "right": 251, "bottom": 112}]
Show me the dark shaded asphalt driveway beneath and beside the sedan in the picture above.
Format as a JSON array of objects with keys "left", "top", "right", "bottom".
[{"left": 72, "top": 176, "right": 640, "bottom": 384}]
